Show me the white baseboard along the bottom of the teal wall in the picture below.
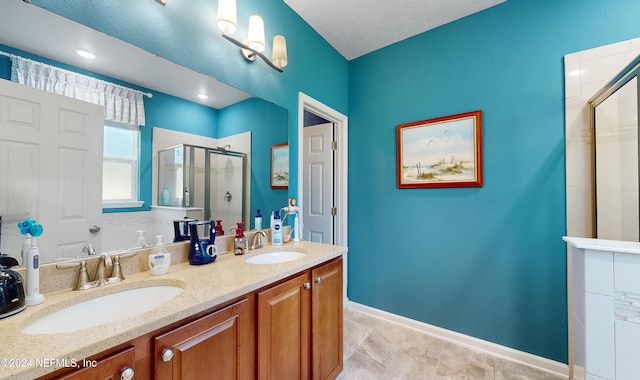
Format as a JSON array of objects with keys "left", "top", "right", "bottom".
[{"left": 345, "top": 301, "right": 569, "bottom": 378}]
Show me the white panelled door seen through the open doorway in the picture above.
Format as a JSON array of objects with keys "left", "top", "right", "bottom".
[{"left": 302, "top": 123, "right": 334, "bottom": 244}]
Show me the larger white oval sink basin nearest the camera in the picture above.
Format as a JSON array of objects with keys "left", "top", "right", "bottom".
[{"left": 22, "top": 285, "right": 183, "bottom": 335}]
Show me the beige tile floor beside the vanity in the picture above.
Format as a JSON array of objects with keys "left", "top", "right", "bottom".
[{"left": 338, "top": 308, "right": 563, "bottom": 380}]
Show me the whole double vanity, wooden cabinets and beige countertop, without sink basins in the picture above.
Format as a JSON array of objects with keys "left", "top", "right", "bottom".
[{"left": 0, "top": 242, "right": 347, "bottom": 380}]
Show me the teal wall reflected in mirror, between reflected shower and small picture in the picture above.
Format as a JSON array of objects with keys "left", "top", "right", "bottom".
[{"left": 218, "top": 98, "right": 289, "bottom": 228}]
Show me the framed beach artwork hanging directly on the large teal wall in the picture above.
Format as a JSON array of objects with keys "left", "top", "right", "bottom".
[{"left": 397, "top": 111, "right": 482, "bottom": 188}]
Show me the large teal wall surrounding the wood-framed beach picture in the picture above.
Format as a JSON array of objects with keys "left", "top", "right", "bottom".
[{"left": 349, "top": 0, "right": 640, "bottom": 362}]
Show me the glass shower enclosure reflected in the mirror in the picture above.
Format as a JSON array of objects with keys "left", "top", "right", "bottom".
[{"left": 158, "top": 144, "right": 247, "bottom": 224}]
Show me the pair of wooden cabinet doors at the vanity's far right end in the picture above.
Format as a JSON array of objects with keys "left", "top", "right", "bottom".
[{"left": 257, "top": 258, "right": 343, "bottom": 380}]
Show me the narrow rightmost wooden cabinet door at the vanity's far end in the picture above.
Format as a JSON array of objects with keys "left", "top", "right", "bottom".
[{"left": 311, "top": 259, "right": 343, "bottom": 380}]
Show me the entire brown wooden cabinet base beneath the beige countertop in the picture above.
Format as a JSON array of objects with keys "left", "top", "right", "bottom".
[{"left": 42, "top": 257, "right": 343, "bottom": 380}]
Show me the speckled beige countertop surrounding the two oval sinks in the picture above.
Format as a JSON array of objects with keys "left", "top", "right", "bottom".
[{"left": 0, "top": 241, "right": 347, "bottom": 379}]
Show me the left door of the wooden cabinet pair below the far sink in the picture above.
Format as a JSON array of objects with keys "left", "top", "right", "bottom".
[{"left": 257, "top": 271, "right": 311, "bottom": 380}]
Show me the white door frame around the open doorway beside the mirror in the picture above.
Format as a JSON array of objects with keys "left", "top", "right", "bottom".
[{"left": 298, "top": 92, "right": 349, "bottom": 246}]
